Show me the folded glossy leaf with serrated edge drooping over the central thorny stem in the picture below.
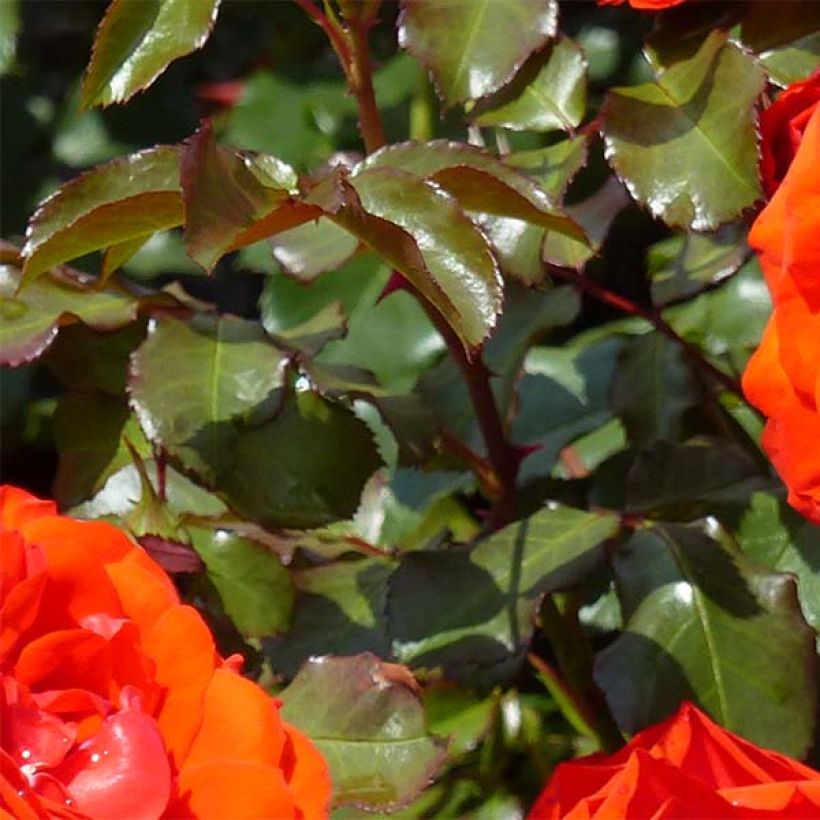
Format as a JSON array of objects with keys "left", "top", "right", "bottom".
[{"left": 333, "top": 168, "right": 502, "bottom": 347}]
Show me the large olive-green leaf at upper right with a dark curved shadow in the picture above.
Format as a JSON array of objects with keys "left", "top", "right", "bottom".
[{"left": 604, "top": 30, "right": 765, "bottom": 231}]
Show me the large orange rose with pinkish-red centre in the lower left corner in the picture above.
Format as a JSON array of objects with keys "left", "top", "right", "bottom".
[{"left": 0, "top": 487, "right": 330, "bottom": 820}]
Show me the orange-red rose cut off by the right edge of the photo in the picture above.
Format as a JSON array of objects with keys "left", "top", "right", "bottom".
[{"left": 743, "top": 72, "right": 820, "bottom": 523}]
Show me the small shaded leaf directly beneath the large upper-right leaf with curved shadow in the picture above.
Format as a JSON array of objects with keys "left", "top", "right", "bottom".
[{"left": 647, "top": 222, "right": 750, "bottom": 305}]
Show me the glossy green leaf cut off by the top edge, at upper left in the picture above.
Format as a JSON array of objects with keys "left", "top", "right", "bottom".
[{"left": 82, "top": 0, "right": 219, "bottom": 108}]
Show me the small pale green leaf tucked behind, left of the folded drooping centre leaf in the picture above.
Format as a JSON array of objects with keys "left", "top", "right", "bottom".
[{"left": 270, "top": 219, "right": 359, "bottom": 282}]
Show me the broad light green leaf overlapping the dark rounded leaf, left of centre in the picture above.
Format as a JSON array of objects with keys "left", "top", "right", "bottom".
[{"left": 129, "top": 315, "right": 287, "bottom": 475}]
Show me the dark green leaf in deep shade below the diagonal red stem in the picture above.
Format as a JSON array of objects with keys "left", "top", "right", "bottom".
[{"left": 612, "top": 332, "right": 701, "bottom": 445}]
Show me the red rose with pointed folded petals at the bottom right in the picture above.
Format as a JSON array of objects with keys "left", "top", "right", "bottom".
[{"left": 530, "top": 703, "right": 820, "bottom": 820}]
